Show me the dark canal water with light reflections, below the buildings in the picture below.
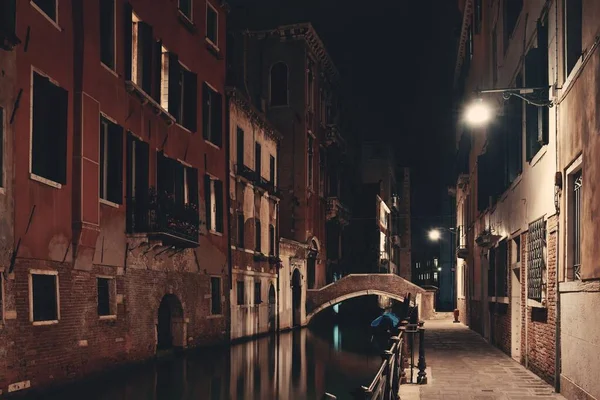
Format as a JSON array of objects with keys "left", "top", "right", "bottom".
[{"left": 22, "top": 318, "right": 382, "bottom": 400}]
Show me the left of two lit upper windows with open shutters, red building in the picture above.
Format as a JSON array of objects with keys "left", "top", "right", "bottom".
[{"left": 125, "top": 10, "right": 155, "bottom": 95}]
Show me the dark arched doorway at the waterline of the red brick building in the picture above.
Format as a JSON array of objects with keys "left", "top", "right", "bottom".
[{"left": 156, "top": 294, "right": 185, "bottom": 351}]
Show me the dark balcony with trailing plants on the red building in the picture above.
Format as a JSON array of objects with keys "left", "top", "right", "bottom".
[{"left": 127, "top": 188, "right": 200, "bottom": 248}]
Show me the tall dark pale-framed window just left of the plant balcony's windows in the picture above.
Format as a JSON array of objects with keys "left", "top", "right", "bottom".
[{"left": 99, "top": 117, "right": 123, "bottom": 204}]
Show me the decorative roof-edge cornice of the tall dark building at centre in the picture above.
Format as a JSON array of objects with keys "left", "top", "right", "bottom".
[{"left": 247, "top": 22, "right": 340, "bottom": 83}]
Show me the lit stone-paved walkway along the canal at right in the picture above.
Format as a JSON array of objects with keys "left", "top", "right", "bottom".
[{"left": 400, "top": 315, "right": 564, "bottom": 400}]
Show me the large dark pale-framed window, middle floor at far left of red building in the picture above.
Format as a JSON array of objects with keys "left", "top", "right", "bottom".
[{"left": 31, "top": 72, "right": 69, "bottom": 184}]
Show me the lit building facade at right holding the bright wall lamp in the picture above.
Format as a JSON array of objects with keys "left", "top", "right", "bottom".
[{"left": 455, "top": 0, "right": 559, "bottom": 390}]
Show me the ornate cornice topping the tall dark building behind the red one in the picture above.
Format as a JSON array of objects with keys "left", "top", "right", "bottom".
[{"left": 246, "top": 22, "right": 340, "bottom": 81}]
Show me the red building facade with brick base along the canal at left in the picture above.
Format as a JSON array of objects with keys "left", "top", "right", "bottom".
[{"left": 0, "top": 0, "right": 229, "bottom": 391}]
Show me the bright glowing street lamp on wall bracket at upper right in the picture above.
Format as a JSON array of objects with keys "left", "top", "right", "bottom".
[{"left": 464, "top": 87, "right": 554, "bottom": 126}]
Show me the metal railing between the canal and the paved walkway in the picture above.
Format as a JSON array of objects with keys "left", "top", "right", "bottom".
[{"left": 323, "top": 321, "right": 427, "bottom": 400}]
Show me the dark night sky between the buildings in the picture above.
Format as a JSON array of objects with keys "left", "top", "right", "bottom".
[{"left": 229, "top": 0, "right": 460, "bottom": 252}]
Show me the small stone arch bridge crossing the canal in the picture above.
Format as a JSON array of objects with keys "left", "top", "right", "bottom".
[{"left": 306, "top": 274, "right": 435, "bottom": 323}]
